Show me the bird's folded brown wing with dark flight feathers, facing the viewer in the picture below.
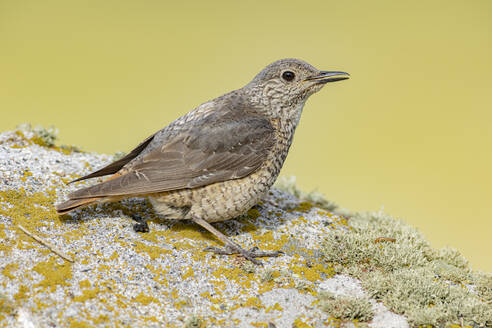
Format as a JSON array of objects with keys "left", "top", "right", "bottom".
[{"left": 69, "top": 112, "right": 275, "bottom": 199}]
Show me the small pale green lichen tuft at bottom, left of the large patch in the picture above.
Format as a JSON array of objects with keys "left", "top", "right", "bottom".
[{"left": 318, "top": 292, "right": 374, "bottom": 322}]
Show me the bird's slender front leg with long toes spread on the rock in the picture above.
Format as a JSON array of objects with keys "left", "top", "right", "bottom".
[{"left": 192, "top": 216, "right": 283, "bottom": 265}]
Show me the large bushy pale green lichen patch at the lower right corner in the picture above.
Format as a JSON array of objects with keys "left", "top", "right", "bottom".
[{"left": 322, "top": 212, "right": 492, "bottom": 327}]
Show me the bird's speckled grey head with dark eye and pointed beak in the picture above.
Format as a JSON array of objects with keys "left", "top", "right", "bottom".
[{"left": 245, "top": 58, "right": 350, "bottom": 120}]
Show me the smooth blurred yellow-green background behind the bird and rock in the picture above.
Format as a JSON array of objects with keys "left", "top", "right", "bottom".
[{"left": 0, "top": 0, "right": 492, "bottom": 271}]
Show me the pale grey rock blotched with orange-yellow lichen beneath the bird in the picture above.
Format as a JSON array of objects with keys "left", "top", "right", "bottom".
[{"left": 0, "top": 128, "right": 491, "bottom": 328}]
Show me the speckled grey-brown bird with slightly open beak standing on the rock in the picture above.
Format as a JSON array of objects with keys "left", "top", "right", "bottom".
[{"left": 55, "top": 58, "right": 350, "bottom": 264}]
